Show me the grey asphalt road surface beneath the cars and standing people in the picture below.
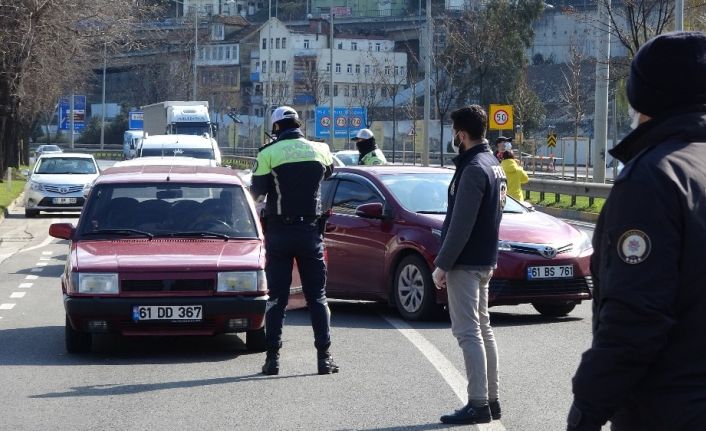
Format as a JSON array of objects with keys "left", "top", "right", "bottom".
[{"left": 0, "top": 207, "right": 590, "bottom": 431}]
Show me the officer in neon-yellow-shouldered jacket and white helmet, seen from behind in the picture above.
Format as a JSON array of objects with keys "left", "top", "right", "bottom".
[{"left": 250, "top": 106, "right": 338, "bottom": 375}]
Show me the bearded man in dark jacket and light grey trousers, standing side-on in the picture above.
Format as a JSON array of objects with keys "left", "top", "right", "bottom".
[{"left": 433, "top": 105, "right": 507, "bottom": 424}]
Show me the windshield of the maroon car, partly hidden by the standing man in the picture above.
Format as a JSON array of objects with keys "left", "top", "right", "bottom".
[{"left": 380, "top": 171, "right": 527, "bottom": 214}]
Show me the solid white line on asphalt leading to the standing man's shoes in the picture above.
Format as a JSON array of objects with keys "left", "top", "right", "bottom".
[{"left": 383, "top": 316, "right": 506, "bottom": 431}]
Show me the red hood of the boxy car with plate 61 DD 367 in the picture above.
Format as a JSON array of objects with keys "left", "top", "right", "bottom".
[{"left": 74, "top": 238, "right": 264, "bottom": 272}]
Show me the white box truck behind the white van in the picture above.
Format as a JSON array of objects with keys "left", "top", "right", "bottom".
[{"left": 142, "top": 101, "right": 216, "bottom": 136}]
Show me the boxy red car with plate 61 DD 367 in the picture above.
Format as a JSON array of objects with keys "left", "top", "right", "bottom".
[{"left": 49, "top": 166, "right": 267, "bottom": 352}]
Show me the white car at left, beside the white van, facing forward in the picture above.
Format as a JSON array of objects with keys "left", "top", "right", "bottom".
[{"left": 24, "top": 153, "right": 100, "bottom": 217}]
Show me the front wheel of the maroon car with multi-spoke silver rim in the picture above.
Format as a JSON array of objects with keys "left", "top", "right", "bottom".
[{"left": 393, "top": 255, "right": 440, "bottom": 320}]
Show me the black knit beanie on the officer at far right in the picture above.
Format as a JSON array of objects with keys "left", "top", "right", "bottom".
[{"left": 627, "top": 31, "right": 706, "bottom": 117}]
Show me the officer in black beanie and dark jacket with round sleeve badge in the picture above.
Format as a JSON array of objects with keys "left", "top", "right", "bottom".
[{"left": 568, "top": 32, "right": 706, "bottom": 431}]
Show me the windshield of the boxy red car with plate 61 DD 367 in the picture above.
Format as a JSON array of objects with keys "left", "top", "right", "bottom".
[{"left": 79, "top": 182, "right": 258, "bottom": 239}]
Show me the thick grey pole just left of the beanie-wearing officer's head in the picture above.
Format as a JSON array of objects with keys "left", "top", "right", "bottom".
[{"left": 586, "top": 0, "right": 611, "bottom": 183}]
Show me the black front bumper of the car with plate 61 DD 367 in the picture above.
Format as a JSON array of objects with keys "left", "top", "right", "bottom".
[{"left": 64, "top": 295, "right": 268, "bottom": 335}]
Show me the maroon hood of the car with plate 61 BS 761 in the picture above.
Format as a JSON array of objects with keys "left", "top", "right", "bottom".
[{"left": 424, "top": 211, "right": 578, "bottom": 245}]
